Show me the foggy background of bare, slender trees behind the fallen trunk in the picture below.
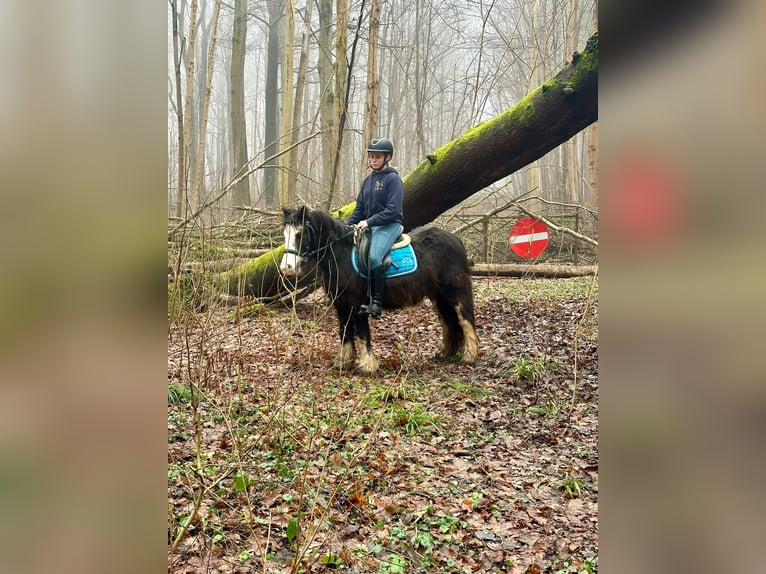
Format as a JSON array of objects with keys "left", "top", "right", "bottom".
[{"left": 168, "top": 0, "right": 598, "bottom": 264}]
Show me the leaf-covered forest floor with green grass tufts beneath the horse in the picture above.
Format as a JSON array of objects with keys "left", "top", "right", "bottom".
[{"left": 168, "top": 277, "right": 599, "bottom": 574}]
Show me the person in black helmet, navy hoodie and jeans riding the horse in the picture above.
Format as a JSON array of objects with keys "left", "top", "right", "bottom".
[{"left": 346, "top": 137, "right": 404, "bottom": 317}]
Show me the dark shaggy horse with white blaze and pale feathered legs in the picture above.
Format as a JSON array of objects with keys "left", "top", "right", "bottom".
[{"left": 280, "top": 206, "right": 479, "bottom": 374}]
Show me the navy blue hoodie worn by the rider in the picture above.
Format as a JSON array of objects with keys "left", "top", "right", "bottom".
[{"left": 346, "top": 167, "right": 404, "bottom": 227}]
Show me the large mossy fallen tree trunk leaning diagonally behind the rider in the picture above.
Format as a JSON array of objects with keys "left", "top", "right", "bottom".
[{"left": 222, "top": 32, "right": 598, "bottom": 297}]
